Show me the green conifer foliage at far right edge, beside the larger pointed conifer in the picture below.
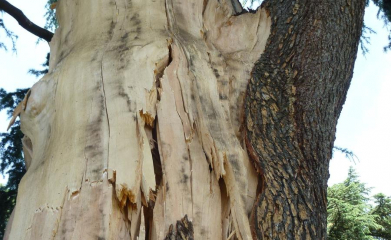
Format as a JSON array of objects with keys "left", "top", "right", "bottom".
[{"left": 370, "top": 193, "right": 391, "bottom": 240}]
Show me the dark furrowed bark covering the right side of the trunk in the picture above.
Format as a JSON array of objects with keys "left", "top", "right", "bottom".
[{"left": 245, "top": 0, "right": 365, "bottom": 239}]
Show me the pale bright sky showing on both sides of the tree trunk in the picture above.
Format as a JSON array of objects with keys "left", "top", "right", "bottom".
[{"left": 0, "top": 0, "right": 391, "bottom": 196}]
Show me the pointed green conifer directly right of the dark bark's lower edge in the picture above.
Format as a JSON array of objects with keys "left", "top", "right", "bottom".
[{"left": 327, "top": 168, "right": 381, "bottom": 240}]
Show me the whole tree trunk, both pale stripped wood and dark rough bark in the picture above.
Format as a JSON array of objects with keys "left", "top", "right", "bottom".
[{"left": 6, "top": 0, "right": 365, "bottom": 240}]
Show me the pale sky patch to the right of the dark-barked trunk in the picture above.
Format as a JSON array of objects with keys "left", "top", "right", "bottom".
[{"left": 329, "top": 5, "right": 391, "bottom": 196}]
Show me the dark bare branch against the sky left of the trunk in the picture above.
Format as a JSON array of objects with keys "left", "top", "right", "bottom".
[{"left": 0, "top": 0, "right": 53, "bottom": 42}]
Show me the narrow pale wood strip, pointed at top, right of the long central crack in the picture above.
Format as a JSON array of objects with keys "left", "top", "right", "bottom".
[{"left": 157, "top": 69, "right": 193, "bottom": 230}]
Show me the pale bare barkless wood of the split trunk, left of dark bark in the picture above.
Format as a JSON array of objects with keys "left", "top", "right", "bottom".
[{"left": 9, "top": 0, "right": 271, "bottom": 239}]
